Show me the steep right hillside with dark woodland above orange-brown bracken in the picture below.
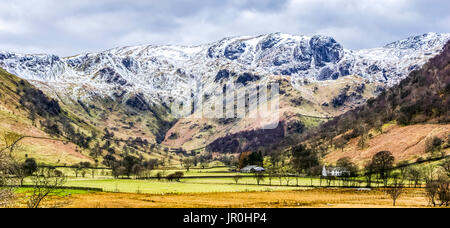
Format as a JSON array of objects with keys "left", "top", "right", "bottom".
[{"left": 307, "top": 42, "right": 450, "bottom": 164}]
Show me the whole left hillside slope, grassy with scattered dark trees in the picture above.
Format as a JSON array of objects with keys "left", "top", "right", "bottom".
[{"left": 0, "top": 68, "right": 179, "bottom": 166}]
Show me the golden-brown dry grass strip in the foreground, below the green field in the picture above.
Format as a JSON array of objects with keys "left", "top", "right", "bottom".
[{"left": 41, "top": 189, "right": 427, "bottom": 208}]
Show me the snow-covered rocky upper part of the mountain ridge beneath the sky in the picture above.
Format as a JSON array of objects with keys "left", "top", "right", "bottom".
[{"left": 0, "top": 33, "right": 450, "bottom": 103}]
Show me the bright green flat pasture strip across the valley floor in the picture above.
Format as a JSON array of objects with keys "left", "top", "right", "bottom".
[{"left": 21, "top": 167, "right": 372, "bottom": 194}]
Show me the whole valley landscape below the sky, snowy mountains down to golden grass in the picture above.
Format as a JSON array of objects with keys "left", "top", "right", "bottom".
[{"left": 0, "top": 33, "right": 450, "bottom": 207}]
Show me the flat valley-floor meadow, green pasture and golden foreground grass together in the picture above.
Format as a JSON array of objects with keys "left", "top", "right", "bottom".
[{"left": 11, "top": 164, "right": 442, "bottom": 208}]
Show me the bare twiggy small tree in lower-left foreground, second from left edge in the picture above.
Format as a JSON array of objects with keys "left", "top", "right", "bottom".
[{"left": 27, "top": 169, "right": 66, "bottom": 208}]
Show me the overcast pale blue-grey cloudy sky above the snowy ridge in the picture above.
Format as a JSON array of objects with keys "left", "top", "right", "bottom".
[{"left": 0, "top": 0, "right": 450, "bottom": 56}]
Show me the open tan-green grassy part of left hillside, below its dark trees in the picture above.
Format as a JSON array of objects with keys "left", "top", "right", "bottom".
[{"left": 0, "top": 69, "right": 94, "bottom": 165}]
